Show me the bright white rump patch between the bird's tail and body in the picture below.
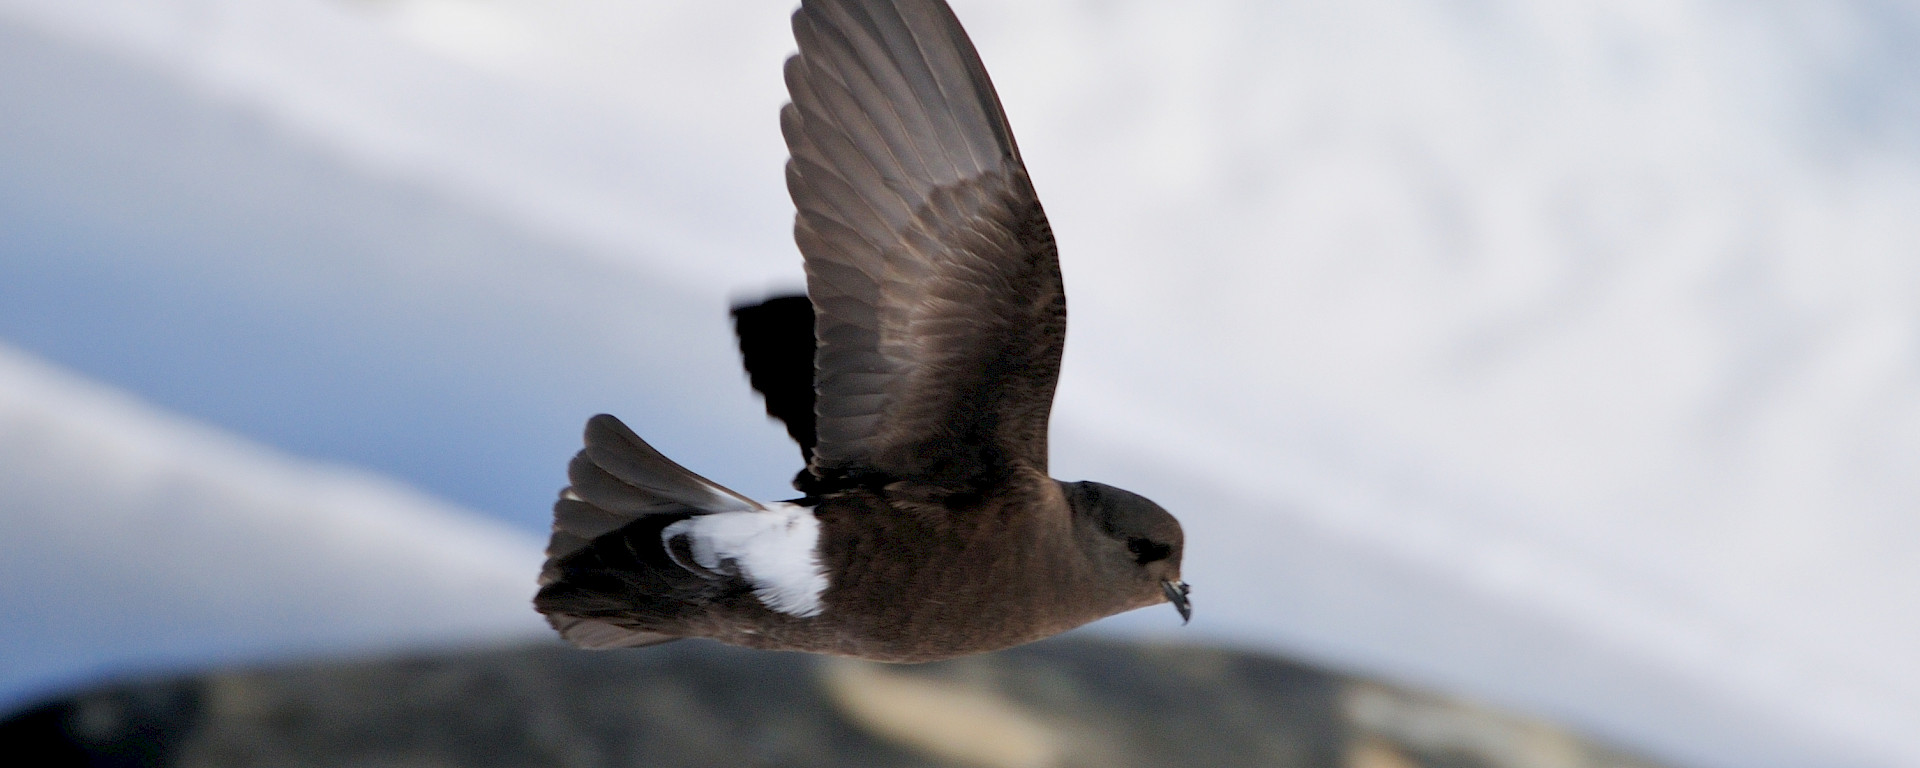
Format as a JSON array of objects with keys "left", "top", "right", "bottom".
[{"left": 660, "top": 503, "right": 828, "bottom": 616}]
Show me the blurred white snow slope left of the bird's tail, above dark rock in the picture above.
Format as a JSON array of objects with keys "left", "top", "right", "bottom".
[{"left": 0, "top": 346, "right": 545, "bottom": 710}]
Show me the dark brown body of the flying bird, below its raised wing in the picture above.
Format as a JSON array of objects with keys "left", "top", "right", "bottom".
[{"left": 560, "top": 474, "right": 1164, "bottom": 662}]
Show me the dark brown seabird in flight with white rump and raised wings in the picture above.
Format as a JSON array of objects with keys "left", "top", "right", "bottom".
[{"left": 534, "top": 0, "right": 1192, "bottom": 662}]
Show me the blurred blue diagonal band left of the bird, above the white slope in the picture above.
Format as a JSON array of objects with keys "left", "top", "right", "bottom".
[{"left": 0, "top": 16, "right": 797, "bottom": 532}]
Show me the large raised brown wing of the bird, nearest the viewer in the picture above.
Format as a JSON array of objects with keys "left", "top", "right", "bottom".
[{"left": 780, "top": 0, "right": 1066, "bottom": 488}]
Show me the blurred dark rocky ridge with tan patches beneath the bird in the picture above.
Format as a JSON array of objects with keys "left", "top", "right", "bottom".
[{"left": 0, "top": 637, "right": 1651, "bottom": 768}]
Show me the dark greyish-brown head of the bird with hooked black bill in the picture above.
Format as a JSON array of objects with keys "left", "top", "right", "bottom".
[{"left": 1060, "top": 482, "right": 1192, "bottom": 624}]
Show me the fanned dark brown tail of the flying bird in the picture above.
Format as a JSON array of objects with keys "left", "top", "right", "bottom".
[{"left": 534, "top": 415, "right": 762, "bottom": 649}]
